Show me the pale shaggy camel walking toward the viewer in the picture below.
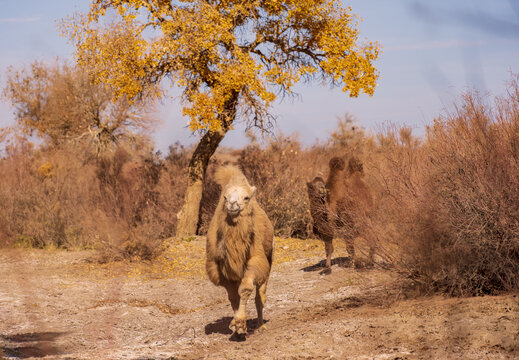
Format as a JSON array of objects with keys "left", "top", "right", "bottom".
[{"left": 206, "top": 165, "right": 274, "bottom": 335}]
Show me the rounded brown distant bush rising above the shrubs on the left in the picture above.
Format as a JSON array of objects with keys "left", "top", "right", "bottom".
[{"left": 0, "top": 60, "right": 154, "bottom": 148}]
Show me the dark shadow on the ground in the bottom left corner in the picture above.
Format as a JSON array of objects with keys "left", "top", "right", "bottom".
[{"left": 0, "top": 332, "right": 67, "bottom": 359}]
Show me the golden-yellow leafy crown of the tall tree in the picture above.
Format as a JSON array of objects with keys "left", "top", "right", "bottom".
[{"left": 63, "top": 0, "right": 379, "bottom": 131}]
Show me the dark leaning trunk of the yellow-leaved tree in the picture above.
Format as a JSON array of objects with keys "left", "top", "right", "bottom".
[{"left": 176, "top": 93, "right": 239, "bottom": 238}]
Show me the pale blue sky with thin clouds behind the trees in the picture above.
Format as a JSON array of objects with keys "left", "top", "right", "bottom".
[{"left": 0, "top": 0, "right": 519, "bottom": 151}]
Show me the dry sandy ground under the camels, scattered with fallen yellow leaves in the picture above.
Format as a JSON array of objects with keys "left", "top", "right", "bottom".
[{"left": 0, "top": 238, "right": 519, "bottom": 360}]
